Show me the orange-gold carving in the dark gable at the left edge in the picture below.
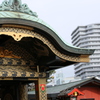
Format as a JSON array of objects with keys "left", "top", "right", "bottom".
[{"left": 0, "top": 47, "right": 21, "bottom": 58}]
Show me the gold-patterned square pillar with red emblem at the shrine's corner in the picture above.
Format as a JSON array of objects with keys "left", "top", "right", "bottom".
[{"left": 35, "top": 78, "right": 47, "bottom": 100}]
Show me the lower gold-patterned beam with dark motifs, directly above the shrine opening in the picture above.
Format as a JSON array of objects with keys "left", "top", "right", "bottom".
[{"left": 0, "top": 65, "right": 46, "bottom": 78}]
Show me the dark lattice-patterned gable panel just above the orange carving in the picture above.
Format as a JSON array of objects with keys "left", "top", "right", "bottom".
[{"left": 3, "top": 40, "right": 35, "bottom": 60}]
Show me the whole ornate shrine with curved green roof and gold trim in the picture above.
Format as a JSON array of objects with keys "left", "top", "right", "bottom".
[{"left": 0, "top": 0, "right": 94, "bottom": 100}]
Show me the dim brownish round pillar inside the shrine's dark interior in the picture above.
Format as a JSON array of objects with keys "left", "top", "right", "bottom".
[{"left": 19, "top": 83, "right": 28, "bottom": 100}]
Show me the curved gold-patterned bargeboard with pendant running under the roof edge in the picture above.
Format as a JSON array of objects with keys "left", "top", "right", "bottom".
[{"left": 0, "top": 27, "right": 89, "bottom": 62}]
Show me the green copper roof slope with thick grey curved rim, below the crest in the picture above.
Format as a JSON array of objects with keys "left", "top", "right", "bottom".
[{"left": 0, "top": 11, "right": 94, "bottom": 55}]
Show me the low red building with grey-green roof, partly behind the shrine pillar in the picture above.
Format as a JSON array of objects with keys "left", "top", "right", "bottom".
[{"left": 28, "top": 77, "right": 100, "bottom": 100}]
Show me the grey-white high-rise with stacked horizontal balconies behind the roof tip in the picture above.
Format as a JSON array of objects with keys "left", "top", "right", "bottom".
[{"left": 71, "top": 24, "right": 100, "bottom": 78}]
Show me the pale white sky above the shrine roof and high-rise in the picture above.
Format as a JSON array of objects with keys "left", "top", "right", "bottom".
[{"left": 0, "top": 0, "right": 100, "bottom": 77}]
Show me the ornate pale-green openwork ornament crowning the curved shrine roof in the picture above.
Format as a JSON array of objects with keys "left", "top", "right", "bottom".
[{"left": 0, "top": 0, "right": 38, "bottom": 17}]
